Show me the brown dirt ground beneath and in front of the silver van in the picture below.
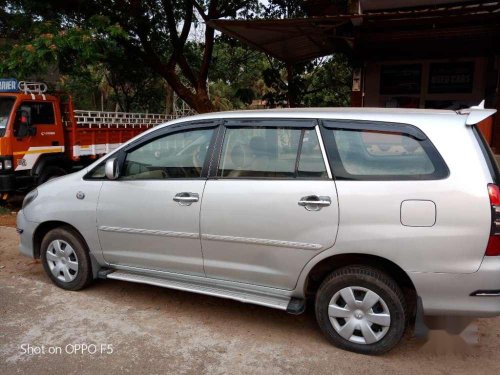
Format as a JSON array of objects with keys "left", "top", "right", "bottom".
[{"left": 0, "top": 227, "right": 500, "bottom": 375}]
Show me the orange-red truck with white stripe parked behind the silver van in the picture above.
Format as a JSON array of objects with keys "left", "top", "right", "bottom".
[{"left": 0, "top": 79, "right": 177, "bottom": 201}]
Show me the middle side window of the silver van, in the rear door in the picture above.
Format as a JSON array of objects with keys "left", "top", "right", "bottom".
[{"left": 218, "top": 127, "right": 327, "bottom": 178}]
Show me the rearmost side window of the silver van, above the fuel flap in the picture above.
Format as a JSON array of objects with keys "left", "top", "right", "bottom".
[{"left": 325, "top": 122, "right": 449, "bottom": 180}]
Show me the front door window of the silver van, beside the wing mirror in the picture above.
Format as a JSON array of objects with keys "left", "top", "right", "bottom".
[{"left": 120, "top": 129, "right": 214, "bottom": 180}]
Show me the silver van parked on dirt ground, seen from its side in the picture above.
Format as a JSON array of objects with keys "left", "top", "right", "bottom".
[{"left": 17, "top": 106, "right": 500, "bottom": 354}]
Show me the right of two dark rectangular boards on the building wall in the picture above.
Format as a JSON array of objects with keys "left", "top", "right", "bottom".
[{"left": 428, "top": 61, "right": 474, "bottom": 94}]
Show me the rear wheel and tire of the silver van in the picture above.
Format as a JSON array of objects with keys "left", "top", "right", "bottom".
[{"left": 315, "top": 265, "right": 407, "bottom": 355}]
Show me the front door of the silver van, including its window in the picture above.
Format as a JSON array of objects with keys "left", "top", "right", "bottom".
[{"left": 97, "top": 127, "right": 215, "bottom": 276}]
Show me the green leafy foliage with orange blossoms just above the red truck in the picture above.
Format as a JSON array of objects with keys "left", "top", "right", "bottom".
[{"left": 0, "top": 6, "right": 170, "bottom": 112}]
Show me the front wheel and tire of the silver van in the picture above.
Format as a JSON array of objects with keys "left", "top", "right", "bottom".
[{"left": 40, "top": 227, "right": 93, "bottom": 290}]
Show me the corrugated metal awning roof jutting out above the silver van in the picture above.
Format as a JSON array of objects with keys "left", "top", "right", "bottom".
[{"left": 209, "top": 1, "right": 500, "bottom": 63}]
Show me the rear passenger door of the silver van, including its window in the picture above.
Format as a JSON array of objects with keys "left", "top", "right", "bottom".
[{"left": 201, "top": 120, "right": 338, "bottom": 290}]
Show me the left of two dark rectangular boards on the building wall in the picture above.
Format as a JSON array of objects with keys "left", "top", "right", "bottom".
[{"left": 380, "top": 64, "right": 422, "bottom": 95}]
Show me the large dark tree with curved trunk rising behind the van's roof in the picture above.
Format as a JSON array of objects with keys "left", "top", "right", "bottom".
[{"left": 0, "top": 0, "right": 258, "bottom": 112}]
